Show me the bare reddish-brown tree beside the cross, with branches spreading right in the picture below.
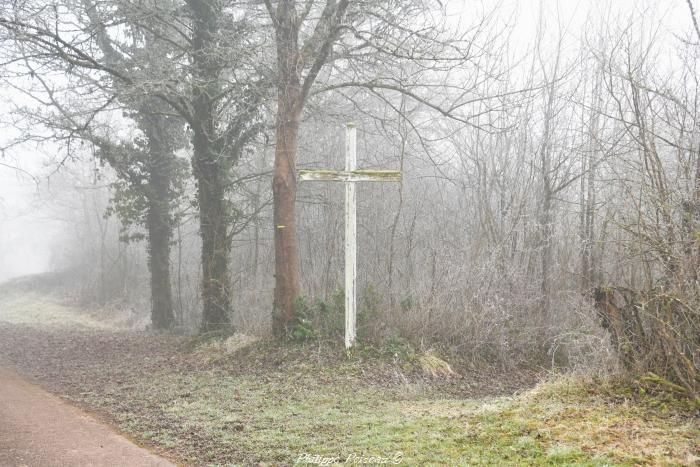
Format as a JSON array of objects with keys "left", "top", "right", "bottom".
[{"left": 264, "top": 0, "right": 500, "bottom": 336}]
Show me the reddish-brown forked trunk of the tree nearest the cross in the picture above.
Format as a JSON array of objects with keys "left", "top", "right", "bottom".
[{"left": 265, "top": 0, "right": 349, "bottom": 337}]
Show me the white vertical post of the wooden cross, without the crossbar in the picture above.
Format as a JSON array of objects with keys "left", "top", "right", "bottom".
[{"left": 345, "top": 123, "right": 357, "bottom": 349}]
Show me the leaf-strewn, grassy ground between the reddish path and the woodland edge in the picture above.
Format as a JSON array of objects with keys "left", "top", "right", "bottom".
[{"left": 0, "top": 293, "right": 700, "bottom": 466}]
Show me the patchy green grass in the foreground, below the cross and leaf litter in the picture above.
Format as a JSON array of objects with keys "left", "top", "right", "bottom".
[{"left": 90, "top": 364, "right": 700, "bottom": 466}]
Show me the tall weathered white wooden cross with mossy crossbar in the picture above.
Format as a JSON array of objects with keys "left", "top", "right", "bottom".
[{"left": 299, "top": 123, "right": 402, "bottom": 349}]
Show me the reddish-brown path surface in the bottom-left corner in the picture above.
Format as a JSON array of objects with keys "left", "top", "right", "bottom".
[{"left": 0, "top": 366, "right": 174, "bottom": 467}]
